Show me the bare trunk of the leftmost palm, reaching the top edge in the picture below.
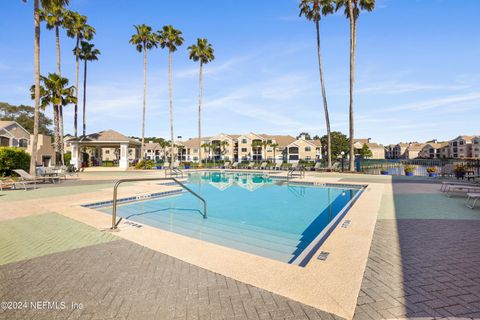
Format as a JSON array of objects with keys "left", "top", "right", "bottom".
[{"left": 30, "top": 0, "right": 40, "bottom": 176}]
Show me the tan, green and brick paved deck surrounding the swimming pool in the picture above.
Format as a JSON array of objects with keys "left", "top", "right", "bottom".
[{"left": 0, "top": 171, "right": 480, "bottom": 319}]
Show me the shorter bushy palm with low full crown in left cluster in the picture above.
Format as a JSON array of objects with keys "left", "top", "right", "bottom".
[{"left": 30, "top": 73, "right": 76, "bottom": 163}]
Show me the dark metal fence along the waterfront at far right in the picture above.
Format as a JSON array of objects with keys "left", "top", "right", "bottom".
[{"left": 356, "top": 159, "right": 480, "bottom": 176}]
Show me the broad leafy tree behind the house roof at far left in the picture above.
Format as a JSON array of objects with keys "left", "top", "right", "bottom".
[{"left": 0, "top": 102, "right": 52, "bottom": 135}]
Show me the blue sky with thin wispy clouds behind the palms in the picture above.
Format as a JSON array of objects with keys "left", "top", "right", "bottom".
[{"left": 0, "top": 0, "right": 480, "bottom": 144}]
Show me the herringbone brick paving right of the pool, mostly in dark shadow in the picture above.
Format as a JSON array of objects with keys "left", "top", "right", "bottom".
[{"left": 355, "top": 219, "right": 480, "bottom": 319}]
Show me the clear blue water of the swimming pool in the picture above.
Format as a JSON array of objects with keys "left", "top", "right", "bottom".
[{"left": 99, "top": 172, "right": 359, "bottom": 264}]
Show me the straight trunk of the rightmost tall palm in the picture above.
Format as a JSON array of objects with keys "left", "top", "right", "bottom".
[{"left": 348, "top": 0, "right": 356, "bottom": 171}]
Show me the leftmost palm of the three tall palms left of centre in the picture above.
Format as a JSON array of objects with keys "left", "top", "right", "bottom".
[{"left": 129, "top": 24, "right": 158, "bottom": 160}]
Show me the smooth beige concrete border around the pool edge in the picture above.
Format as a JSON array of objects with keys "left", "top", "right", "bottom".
[{"left": 44, "top": 174, "right": 382, "bottom": 319}]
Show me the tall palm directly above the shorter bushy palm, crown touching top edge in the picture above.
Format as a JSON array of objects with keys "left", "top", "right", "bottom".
[{"left": 40, "top": 0, "right": 69, "bottom": 164}]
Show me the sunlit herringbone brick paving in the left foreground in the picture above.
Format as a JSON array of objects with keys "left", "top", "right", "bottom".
[{"left": 0, "top": 240, "right": 344, "bottom": 320}]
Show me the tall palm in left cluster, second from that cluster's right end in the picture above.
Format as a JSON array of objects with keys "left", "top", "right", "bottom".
[{"left": 65, "top": 11, "right": 95, "bottom": 137}]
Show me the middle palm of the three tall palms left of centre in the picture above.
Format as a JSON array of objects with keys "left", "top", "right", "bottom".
[{"left": 157, "top": 25, "right": 184, "bottom": 169}]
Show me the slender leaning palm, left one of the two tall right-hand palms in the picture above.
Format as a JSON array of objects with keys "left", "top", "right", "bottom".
[{"left": 299, "top": 0, "right": 334, "bottom": 168}]
